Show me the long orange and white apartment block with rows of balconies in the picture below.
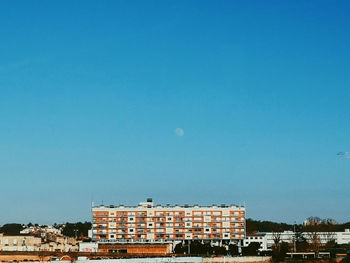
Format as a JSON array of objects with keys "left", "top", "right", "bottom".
[{"left": 92, "top": 198, "right": 245, "bottom": 242}]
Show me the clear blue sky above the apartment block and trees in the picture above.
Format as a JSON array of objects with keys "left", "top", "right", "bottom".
[{"left": 0, "top": 0, "right": 350, "bottom": 224}]
